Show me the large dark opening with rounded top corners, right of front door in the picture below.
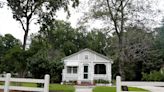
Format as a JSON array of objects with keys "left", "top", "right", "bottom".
[{"left": 94, "top": 64, "right": 106, "bottom": 74}]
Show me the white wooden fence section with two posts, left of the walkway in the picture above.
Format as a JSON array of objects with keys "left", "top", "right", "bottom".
[{"left": 0, "top": 73, "right": 50, "bottom": 92}]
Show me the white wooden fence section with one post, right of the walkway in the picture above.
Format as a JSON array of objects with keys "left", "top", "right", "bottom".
[{"left": 116, "top": 76, "right": 164, "bottom": 92}]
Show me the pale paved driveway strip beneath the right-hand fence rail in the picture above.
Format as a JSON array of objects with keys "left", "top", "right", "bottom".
[{"left": 136, "top": 86, "right": 164, "bottom": 92}]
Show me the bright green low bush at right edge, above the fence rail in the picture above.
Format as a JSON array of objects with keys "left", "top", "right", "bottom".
[{"left": 142, "top": 70, "right": 164, "bottom": 81}]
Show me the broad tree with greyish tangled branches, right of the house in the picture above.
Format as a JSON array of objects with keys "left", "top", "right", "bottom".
[{"left": 111, "top": 27, "right": 163, "bottom": 81}]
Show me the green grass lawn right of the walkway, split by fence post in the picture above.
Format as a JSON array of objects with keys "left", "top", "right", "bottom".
[{"left": 93, "top": 86, "right": 149, "bottom": 92}]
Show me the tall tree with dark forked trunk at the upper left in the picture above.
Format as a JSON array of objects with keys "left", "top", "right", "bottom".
[{"left": 7, "top": 0, "right": 79, "bottom": 50}]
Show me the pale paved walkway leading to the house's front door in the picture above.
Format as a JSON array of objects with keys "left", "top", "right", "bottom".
[{"left": 75, "top": 86, "right": 93, "bottom": 92}]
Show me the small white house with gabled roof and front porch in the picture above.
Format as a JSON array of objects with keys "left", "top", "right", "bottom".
[{"left": 62, "top": 49, "right": 113, "bottom": 84}]
